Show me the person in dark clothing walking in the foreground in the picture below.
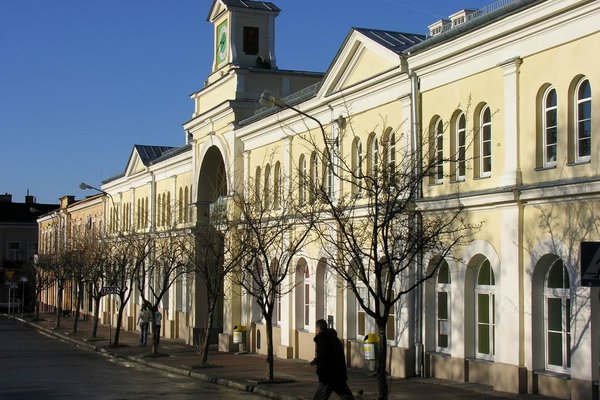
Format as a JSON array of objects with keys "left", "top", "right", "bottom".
[{"left": 310, "top": 319, "right": 354, "bottom": 400}]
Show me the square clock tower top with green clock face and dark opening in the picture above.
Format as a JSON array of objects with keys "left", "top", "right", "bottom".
[{"left": 208, "top": 0, "right": 281, "bottom": 72}]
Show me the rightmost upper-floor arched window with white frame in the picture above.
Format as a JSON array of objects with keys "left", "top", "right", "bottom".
[{"left": 575, "top": 78, "right": 592, "bottom": 161}]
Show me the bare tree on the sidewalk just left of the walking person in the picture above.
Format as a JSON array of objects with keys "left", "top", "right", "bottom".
[{"left": 232, "top": 170, "right": 316, "bottom": 380}]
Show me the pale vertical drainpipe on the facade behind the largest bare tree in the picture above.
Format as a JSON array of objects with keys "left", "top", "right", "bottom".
[{"left": 409, "top": 70, "right": 424, "bottom": 376}]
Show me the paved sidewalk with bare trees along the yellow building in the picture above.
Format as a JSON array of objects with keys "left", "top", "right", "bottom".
[{"left": 3, "top": 314, "right": 548, "bottom": 400}]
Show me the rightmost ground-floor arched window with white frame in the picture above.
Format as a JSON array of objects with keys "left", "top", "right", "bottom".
[{"left": 544, "top": 259, "right": 571, "bottom": 372}]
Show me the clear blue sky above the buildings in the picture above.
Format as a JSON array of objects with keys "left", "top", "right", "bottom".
[{"left": 0, "top": 0, "right": 492, "bottom": 203}]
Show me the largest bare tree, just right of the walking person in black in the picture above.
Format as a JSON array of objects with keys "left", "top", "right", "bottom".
[{"left": 306, "top": 116, "right": 477, "bottom": 399}]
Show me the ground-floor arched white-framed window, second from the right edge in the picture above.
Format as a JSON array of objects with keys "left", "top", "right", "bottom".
[{"left": 475, "top": 259, "right": 496, "bottom": 360}]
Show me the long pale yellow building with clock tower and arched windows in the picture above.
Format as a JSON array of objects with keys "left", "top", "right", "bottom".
[{"left": 77, "top": 0, "right": 600, "bottom": 399}]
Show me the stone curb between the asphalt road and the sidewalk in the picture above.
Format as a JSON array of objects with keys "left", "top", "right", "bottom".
[{"left": 1, "top": 314, "right": 303, "bottom": 400}]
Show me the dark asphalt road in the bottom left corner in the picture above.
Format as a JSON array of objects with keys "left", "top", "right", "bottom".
[{"left": 0, "top": 317, "right": 263, "bottom": 400}]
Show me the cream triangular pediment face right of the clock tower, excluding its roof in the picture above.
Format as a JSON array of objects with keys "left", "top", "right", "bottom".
[{"left": 320, "top": 29, "right": 402, "bottom": 96}]
